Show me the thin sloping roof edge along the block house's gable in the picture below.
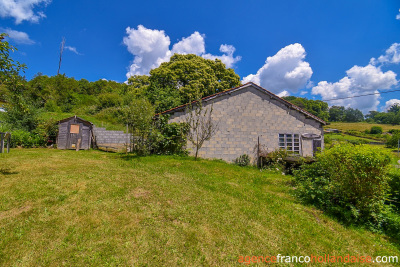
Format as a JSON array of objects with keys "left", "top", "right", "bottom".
[{"left": 156, "top": 82, "right": 326, "bottom": 125}]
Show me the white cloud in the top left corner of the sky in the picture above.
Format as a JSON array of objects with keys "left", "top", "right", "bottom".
[{"left": 0, "top": 0, "right": 51, "bottom": 24}]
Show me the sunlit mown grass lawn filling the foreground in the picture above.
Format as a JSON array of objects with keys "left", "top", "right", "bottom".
[{"left": 0, "top": 149, "right": 400, "bottom": 266}]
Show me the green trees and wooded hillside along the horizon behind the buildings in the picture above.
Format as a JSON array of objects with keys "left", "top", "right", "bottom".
[{"left": 0, "top": 34, "right": 400, "bottom": 143}]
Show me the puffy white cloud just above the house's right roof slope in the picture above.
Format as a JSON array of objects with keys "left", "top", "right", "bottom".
[{"left": 243, "top": 43, "right": 313, "bottom": 94}]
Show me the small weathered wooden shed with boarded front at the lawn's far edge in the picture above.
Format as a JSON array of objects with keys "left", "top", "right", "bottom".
[{"left": 57, "top": 116, "right": 93, "bottom": 150}]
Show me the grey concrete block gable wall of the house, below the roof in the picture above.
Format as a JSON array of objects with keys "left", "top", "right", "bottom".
[{"left": 170, "top": 86, "right": 323, "bottom": 162}]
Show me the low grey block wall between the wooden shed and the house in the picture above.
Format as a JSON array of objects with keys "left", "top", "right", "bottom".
[{"left": 93, "top": 127, "right": 131, "bottom": 150}]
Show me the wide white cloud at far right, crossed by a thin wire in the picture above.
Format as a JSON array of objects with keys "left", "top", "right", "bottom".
[{"left": 312, "top": 64, "right": 398, "bottom": 113}]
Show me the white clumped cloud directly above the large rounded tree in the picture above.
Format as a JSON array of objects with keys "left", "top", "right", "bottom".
[{"left": 123, "top": 25, "right": 240, "bottom": 78}]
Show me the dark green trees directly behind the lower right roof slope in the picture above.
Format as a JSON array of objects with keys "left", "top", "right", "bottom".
[{"left": 283, "top": 96, "right": 329, "bottom": 121}]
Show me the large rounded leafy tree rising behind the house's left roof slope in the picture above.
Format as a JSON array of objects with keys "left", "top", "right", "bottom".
[{"left": 146, "top": 54, "right": 240, "bottom": 111}]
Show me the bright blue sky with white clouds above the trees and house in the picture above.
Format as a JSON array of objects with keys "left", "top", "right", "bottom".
[{"left": 0, "top": 0, "right": 400, "bottom": 113}]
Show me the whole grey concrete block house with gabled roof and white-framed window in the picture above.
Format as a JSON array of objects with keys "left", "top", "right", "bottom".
[{"left": 162, "top": 83, "right": 326, "bottom": 162}]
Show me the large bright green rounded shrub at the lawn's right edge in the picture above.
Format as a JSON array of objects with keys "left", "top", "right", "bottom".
[{"left": 295, "top": 143, "right": 390, "bottom": 226}]
